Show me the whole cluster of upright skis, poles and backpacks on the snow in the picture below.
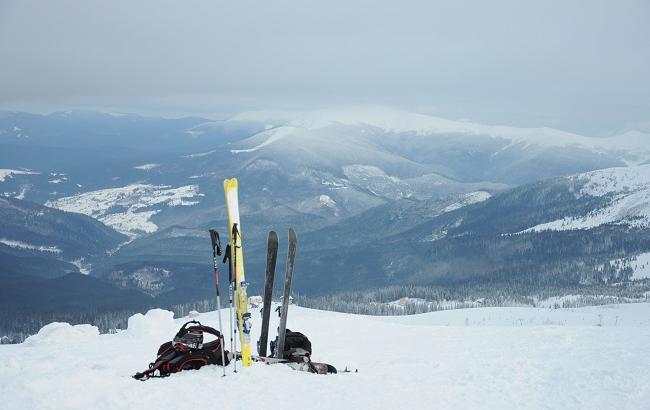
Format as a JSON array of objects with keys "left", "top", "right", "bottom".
[{"left": 133, "top": 178, "right": 336, "bottom": 380}]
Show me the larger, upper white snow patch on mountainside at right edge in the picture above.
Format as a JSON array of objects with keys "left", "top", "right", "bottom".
[{"left": 521, "top": 165, "right": 650, "bottom": 233}]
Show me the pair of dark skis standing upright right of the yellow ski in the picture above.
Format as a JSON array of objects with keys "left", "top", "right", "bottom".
[{"left": 257, "top": 228, "right": 297, "bottom": 359}]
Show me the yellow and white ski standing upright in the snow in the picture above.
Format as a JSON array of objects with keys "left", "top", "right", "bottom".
[{"left": 223, "top": 178, "right": 252, "bottom": 367}]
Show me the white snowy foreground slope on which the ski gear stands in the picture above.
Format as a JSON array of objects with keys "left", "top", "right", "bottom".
[{"left": 0, "top": 303, "right": 650, "bottom": 410}]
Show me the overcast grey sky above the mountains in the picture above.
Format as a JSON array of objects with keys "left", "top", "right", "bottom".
[{"left": 0, "top": 0, "right": 650, "bottom": 135}]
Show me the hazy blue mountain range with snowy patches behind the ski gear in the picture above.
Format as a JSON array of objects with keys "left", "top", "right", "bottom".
[{"left": 0, "top": 107, "right": 650, "bottom": 338}]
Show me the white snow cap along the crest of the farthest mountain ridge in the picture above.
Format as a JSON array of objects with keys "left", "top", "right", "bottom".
[{"left": 230, "top": 106, "right": 650, "bottom": 152}]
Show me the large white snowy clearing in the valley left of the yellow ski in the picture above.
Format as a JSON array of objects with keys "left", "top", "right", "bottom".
[{"left": 45, "top": 184, "right": 202, "bottom": 239}]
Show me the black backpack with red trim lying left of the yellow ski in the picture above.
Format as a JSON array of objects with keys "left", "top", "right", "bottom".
[{"left": 133, "top": 320, "right": 230, "bottom": 380}]
